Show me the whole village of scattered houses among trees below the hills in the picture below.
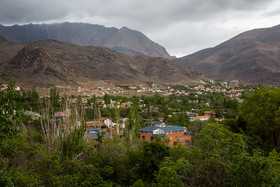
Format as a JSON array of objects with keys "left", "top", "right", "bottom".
[{"left": 5, "top": 80, "right": 253, "bottom": 146}]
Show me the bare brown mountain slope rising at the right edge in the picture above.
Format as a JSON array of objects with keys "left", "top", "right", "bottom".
[{"left": 174, "top": 25, "right": 280, "bottom": 85}]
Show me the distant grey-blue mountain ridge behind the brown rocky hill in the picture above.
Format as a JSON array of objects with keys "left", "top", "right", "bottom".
[{"left": 0, "top": 22, "right": 171, "bottom": 59}]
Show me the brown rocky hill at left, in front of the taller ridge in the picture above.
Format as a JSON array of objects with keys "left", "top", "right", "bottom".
[{"left": 0, "top": 36, "right": 202, "bottom": 88}]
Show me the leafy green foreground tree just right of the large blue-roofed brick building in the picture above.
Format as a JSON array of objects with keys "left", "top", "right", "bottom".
[{"left": 188, "top": 123, "right": 245, "bottom": 186}]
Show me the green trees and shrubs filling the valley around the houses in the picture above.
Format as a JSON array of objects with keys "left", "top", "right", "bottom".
[{"left": 0, "top": 79, "right": 280, "bottom": 186}]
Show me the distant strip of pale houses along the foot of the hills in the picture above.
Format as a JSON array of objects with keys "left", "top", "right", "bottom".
[{"left": 74, "top": 79, "right": 249, "bottom": 102}]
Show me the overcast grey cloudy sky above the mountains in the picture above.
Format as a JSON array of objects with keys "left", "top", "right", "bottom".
[{"left": 0, "top": 0, "right": 280, "bottom": 57}]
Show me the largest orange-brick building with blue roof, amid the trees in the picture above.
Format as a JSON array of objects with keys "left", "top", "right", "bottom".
[{"left": 139, "top": 125, "right": 191, "bottom": 146}]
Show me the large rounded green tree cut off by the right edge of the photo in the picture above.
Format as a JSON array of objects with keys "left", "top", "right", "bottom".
[{"left": 240, "top": 88, "right": 280, "bottom": 152}]
